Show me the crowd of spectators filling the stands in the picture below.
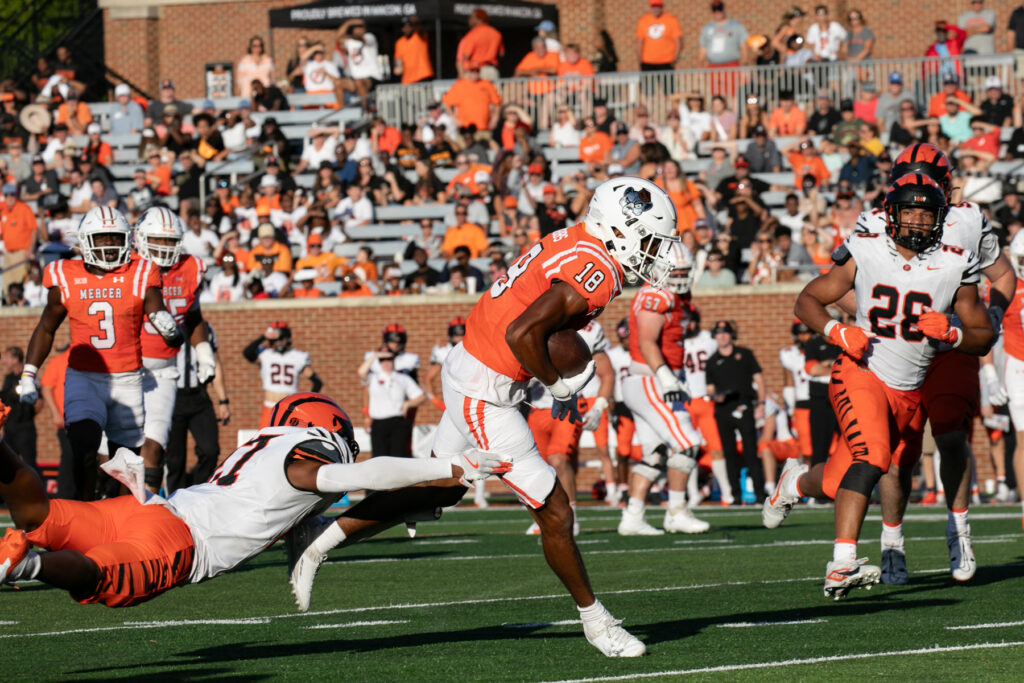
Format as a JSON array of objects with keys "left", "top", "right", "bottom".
[{"left": 0, "top": 0, "right": 1024, "bottom": 305}]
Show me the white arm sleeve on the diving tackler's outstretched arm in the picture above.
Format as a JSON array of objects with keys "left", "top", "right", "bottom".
[{"left": 316, "top": 456, "right": 452, "bottom": 494}]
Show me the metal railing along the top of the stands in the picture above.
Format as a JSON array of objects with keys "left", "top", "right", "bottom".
[{"left": 377, "top": 54, "right": 1021, "bottom": 129}]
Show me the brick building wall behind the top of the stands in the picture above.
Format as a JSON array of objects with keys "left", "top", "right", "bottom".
[{"left": 100, "top": 0, "right": 1018, "bottom": 97}]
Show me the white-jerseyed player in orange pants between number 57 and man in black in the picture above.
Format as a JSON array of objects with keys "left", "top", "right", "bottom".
[{"left": 683, "top": 301, "right": 733, "bottom": 507}]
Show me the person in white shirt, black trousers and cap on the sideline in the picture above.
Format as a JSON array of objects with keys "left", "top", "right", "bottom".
[{"left": 358, "top": 346, "right": 427, "bottom": 458}]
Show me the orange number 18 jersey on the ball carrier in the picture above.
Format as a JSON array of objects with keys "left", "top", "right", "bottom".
[{"left": 463, "top": 223, "right": 624, "bottom": 382}]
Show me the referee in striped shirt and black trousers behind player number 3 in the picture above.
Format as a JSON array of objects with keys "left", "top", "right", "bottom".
[{"left": 164, "top": 322, "right": 231, "bottom": 495}]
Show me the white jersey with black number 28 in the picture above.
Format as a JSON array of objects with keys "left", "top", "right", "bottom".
[{"left": 833, "top": 232, "right": 981, "bottom": 391}]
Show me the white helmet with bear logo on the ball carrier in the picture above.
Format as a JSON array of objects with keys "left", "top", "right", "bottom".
[{"left": 584, "top": 176, "right": 679, "bottom": 287}]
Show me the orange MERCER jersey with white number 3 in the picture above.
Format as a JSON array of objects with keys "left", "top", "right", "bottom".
[{"left": 43, "top": 259, "right": 160, "bottom": 373}]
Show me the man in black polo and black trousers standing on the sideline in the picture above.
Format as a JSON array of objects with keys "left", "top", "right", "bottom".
[{"left": 706, "top": 321, "right": 765, "bottom": 504}]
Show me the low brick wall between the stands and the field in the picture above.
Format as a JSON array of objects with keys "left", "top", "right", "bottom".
[{"left": 0, "top": 285, "right": 988, "bottom": 488}]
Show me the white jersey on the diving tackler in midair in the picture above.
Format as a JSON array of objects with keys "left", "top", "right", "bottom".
[{"left": 167, "top": 427, "right": 343, "bottom": 584}]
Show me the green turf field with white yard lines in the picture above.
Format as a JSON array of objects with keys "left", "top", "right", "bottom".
[{"left": 0, "top": 506, "right": 1024, "bottom": 682}]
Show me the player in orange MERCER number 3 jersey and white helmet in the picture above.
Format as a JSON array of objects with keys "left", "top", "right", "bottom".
[{"left": 20, "top": 206, "right": 184, "bottom": 501}]
